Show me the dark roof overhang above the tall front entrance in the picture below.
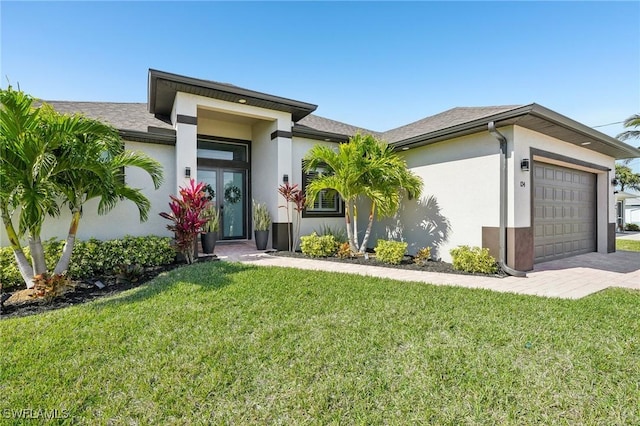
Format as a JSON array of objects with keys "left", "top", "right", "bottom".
[{"left": 148, "top": 69, "right": 318, "bottom": 122}]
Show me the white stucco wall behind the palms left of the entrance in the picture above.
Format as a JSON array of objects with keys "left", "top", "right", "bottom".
[{"left": 0, "top": 141, "right": 176, "bottom": 246}]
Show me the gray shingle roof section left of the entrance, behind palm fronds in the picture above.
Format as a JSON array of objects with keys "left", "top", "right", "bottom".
[{"left": 45, "top": 101, "right": 173, "bottom": 132}]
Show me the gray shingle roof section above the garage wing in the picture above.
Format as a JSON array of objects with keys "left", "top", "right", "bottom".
[{"left": 382, "top": 105, "right": 520, "bottom": 143}]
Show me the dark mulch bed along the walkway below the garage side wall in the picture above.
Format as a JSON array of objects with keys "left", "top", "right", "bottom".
[{"left": 270, "top": 251, "right": 506, "bottom": 278}]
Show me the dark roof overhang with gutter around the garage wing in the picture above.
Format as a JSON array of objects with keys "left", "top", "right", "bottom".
[{"left": 391, "top": 103, "right": 640, "bottom": 160}]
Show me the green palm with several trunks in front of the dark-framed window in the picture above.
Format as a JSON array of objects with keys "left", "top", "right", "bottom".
[{"left": 304, "top": 134, "right": 423, "bottom": 253}]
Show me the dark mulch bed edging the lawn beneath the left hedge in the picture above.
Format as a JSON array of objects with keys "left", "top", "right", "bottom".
[{"left": 0, "top": 257, "right": 218, "bottom": 319}]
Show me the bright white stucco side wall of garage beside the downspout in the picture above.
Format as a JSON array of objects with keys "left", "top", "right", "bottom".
[{"left": 370, "top": 128, "right": 504, "bottom": 261}]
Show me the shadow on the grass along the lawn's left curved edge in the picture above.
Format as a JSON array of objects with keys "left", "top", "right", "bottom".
[{"left": 91, "top": 262, "right": 255, "bottom": 310}]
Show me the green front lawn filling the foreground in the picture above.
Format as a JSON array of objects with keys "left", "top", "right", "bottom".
[{"left": 0, "top": 262, "right": 640, "bottom": 425}]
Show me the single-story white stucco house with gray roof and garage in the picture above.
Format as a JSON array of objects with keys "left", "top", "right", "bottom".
[{"left": 0, "top": 70, "right": 640, "bottom": 271}]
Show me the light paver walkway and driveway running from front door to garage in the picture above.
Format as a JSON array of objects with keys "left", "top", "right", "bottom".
[{"left": 216, "top": 241, "right": 640, "bottom": 299}]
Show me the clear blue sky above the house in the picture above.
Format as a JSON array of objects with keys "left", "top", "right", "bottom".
[{"left": 0, "top": 1, "right": 640, "bottom": 140}]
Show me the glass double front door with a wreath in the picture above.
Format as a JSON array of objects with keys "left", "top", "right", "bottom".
[{"left": 198, "top": 168, "right": 247, "bottom": 240}]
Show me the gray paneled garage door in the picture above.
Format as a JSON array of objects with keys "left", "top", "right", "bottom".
[{"left": 533, "top": 162, "right": 596, "bottom": 262}]
